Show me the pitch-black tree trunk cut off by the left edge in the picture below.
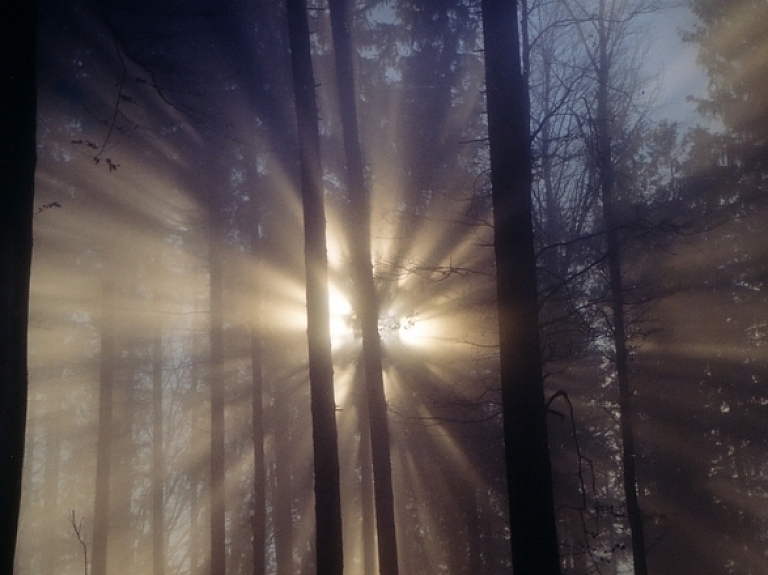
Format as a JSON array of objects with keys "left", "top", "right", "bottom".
[{"left": 0, "top": 2, "right": 37, "bottom": 573}]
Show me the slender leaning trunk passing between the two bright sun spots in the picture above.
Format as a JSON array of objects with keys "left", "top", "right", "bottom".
[{"left": 329, "top": 0, "right": 398, "bottom": 575}]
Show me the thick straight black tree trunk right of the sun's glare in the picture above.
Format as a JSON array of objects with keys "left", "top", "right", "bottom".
[{"left": 482, "top": 0, "right": 560, "bottom": 575}]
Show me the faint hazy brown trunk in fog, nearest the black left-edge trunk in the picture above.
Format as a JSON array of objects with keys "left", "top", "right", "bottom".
[{"left": 91, "top": 276, "right": 115, "bottom": 575}]
